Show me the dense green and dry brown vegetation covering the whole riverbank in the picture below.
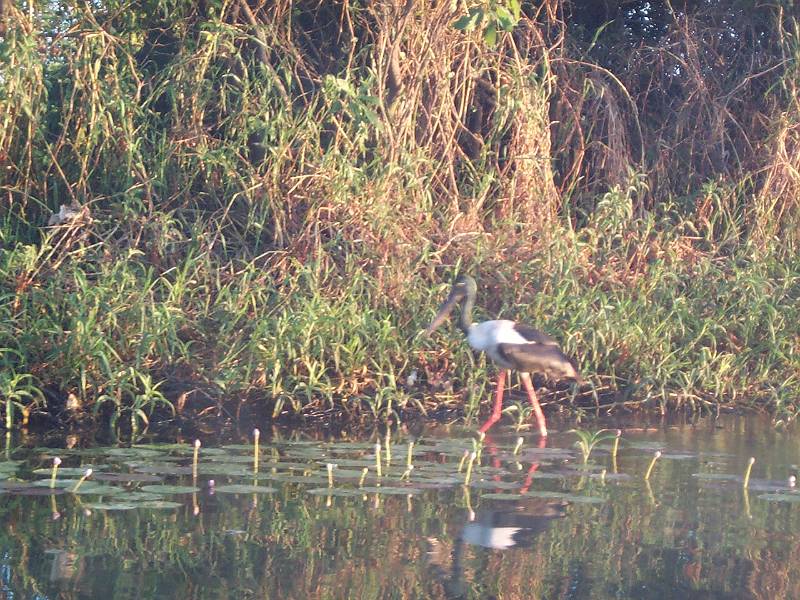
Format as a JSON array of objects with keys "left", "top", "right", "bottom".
[{"left": 0, "top": 0, "right": 800, "bottom": 432}]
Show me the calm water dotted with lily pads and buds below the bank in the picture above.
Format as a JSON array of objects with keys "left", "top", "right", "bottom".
[{"left": 0, "top": 417, "right": 800, "bottom": 599}]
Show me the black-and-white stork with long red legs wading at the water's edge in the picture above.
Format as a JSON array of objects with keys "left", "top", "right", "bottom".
[{"left": 426, "top": 275, "right": 583, "bottom": 437}]
